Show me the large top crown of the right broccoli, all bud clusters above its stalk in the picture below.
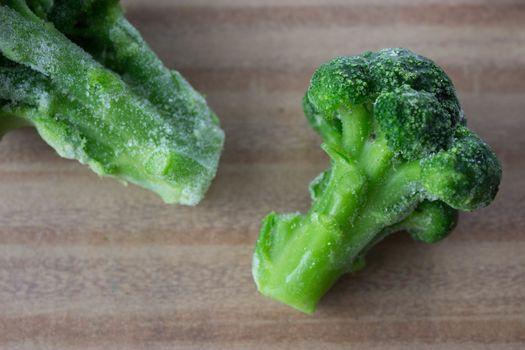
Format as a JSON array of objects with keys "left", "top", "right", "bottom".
[{"left": 303, "top": 49, "right": 464, "bottom": 159}]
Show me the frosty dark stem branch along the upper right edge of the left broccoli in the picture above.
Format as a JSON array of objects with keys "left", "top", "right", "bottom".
[{"left": 48, "top": 1, "right": 222, "bottom": 129}]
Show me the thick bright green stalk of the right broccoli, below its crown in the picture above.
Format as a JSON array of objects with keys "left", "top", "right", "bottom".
[{"left": 253, "top": 111, "right": 420, "bottom": 313}]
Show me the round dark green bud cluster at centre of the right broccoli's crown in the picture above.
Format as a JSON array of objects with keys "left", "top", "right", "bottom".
[{"left": 374, "top": 85, "right": 456, "bottom": 160}]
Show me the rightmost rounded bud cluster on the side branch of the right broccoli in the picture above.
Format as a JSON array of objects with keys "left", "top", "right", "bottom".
[{"left": 421, "top": 126, "right": 501, "bottom": 210}]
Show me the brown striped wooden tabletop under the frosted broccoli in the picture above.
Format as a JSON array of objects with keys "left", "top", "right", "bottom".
[{"left": 0, "top": 0, "right": 525, "bottom": 350}]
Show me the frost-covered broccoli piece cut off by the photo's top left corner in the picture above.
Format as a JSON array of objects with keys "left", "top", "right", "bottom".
[{"left": 0, "top": 0, "right": 224, "bottom": 205}]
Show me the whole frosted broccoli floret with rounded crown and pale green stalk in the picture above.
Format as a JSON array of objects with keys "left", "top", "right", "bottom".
[{"left": 253, "top": 49, "right": 501, "bottom": 313}]
